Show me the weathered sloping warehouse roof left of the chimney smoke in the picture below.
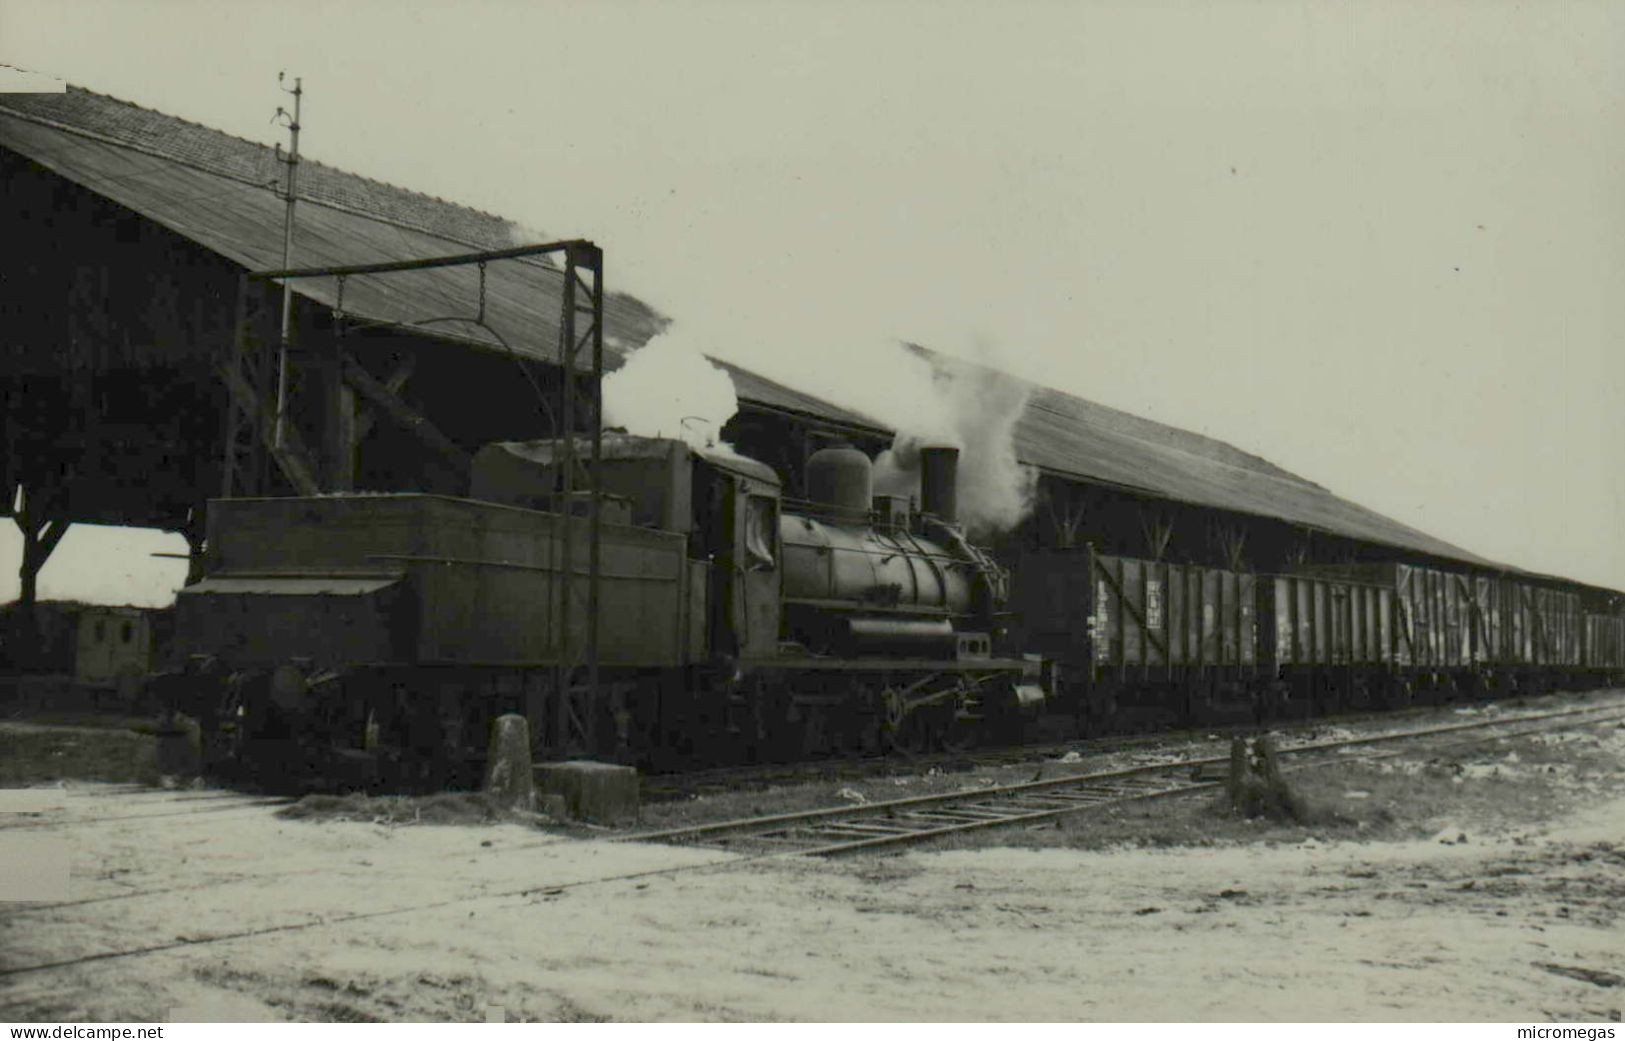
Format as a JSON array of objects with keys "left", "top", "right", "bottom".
[{"left": 0, "top": 88, "right": 890, "bottom": 425}]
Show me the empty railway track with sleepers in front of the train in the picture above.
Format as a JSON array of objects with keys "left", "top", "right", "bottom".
[{"left": 616, "top": 703, "right": 1625, "bottom": 856}]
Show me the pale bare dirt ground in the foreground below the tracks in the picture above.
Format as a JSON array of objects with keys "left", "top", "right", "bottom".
[{"left": 0, "top": 695, "right": 1625, "bottom": 1023}]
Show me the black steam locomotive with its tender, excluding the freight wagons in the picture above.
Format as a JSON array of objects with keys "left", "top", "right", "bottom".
[{"left": 159, "top": 434, "right": 1043, "bottom": 781}]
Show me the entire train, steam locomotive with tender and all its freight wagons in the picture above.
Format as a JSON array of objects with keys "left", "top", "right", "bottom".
[{"left": 154, "top": 434, "right": 1625, "bottom": 783}]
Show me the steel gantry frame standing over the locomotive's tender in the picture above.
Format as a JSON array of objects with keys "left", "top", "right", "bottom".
[{"left": 218, "top": 239, "right": 605, "bottom": 754}]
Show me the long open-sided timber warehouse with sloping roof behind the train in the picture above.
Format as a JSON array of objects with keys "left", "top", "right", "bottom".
[{"left": 0, "top": 88, "right": 1607, "bottom": 623}]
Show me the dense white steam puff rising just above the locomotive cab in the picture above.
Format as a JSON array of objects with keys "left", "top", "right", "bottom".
[{"left": 603, "top": 328, "right": 739, "bottom": 448}]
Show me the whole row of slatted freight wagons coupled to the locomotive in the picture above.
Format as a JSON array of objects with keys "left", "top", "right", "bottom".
[{"left": 1011, "top": 547, "right": 1625, "bottom": 732}]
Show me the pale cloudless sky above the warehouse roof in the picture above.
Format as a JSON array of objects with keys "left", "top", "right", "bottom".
[{"left": 0, "top": 0, "right": 1625, "bottom": 603}]
